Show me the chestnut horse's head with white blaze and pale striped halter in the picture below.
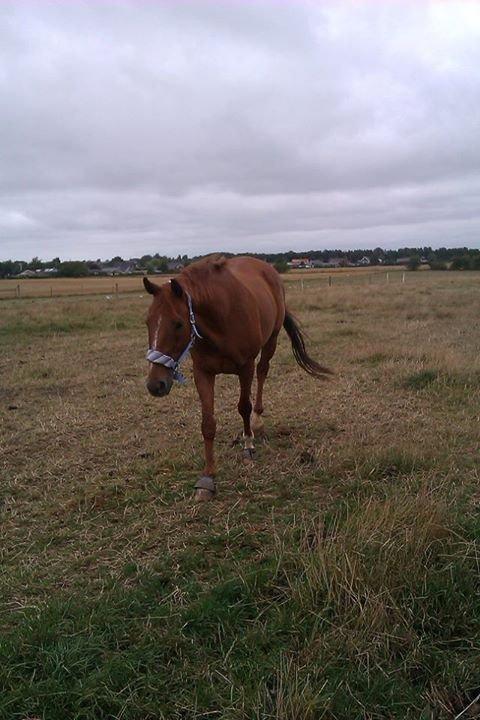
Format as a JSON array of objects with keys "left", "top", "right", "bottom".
[{"left": 143, "top": 277, "right": 191, "bottom": 397}]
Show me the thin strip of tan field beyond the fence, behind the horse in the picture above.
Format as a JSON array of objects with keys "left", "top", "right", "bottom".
[{"left": 0, "top": 266, "right": 404, "bottom": 300}]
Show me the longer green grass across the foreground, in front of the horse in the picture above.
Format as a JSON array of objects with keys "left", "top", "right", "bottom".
[{"left": 0, "top": 488, "right": 480, "bottom": 720}]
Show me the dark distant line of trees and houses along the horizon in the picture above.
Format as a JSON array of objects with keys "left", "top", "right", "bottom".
[{"left": 0, "top": 247, "right": 480, "bottom": 278}]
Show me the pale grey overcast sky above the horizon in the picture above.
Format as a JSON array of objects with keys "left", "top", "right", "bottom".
[{"left": 0, "top": 0, "right": 480, "bottom": 259}]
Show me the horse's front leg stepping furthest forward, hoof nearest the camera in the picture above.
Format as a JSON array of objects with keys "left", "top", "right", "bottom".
[{"left": 193, "top": 366, "right": 217, "bottom": 502}]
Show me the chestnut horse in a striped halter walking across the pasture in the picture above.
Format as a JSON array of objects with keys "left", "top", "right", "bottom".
[{"left": 143, "top": 257, "right": 331, "bottom": 500}]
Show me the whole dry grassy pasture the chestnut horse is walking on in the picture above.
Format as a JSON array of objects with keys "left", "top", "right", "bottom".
[{"left": 0, "top": 272, "right": 480, "bottom": 720}]
